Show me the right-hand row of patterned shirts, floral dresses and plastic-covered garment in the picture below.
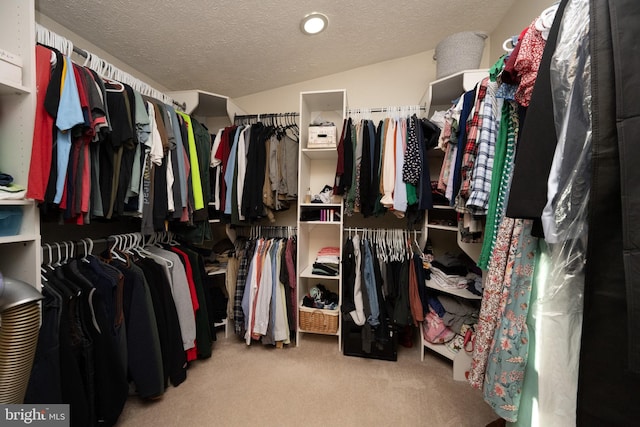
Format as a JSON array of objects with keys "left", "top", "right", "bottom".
[{"left": 434, "top": 5, "right": 576, "bottom": 424}]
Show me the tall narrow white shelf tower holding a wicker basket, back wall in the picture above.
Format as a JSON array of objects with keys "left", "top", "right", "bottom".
[{"left": 296, "top": 89, "right": 347, "bottom": 350}]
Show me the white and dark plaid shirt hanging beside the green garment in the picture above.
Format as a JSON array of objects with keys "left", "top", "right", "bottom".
[{"left": 467, "top": 82, "right": 502, "bottom": 215}]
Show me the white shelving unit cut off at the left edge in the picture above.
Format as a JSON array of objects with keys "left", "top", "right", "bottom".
[{"left": 0, "top": 0, "right": 41, "bottom": 288}]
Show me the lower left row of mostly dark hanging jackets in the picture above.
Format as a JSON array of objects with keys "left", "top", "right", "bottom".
[{"left": 25, "top": 236, "right": 213, "bottom": 426}]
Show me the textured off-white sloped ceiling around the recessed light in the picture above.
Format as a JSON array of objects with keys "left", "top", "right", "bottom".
[{"left": 36, "top": 0, "right": 514, "bottom": 97}]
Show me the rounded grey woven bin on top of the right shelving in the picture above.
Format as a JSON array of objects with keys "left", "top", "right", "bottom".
[{"left": 433, "top": 31, "right": 487, "bottom": 79}]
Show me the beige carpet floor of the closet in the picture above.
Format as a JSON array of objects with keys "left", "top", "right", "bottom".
[{"left": 118, "top": 332, "right": 497, "bottom": 427}]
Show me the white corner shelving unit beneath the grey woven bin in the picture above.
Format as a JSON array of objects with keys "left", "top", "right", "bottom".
[{"left": 420, "top": 69, "right": 488, "bottom": 380}]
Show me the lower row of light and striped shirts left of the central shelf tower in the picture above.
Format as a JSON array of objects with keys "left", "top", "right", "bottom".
[{"left": 228, "top": 229, "right": 297, "bottom": 345}]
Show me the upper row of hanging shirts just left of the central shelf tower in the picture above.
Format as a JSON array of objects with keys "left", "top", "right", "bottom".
[{"left": 210, "top": 117, "right": 298, "bottom": 225}]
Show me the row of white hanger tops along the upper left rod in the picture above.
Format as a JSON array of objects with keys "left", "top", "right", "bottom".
[{"left": 36, "top": 23, "right": 187, "bottom": 111}]
